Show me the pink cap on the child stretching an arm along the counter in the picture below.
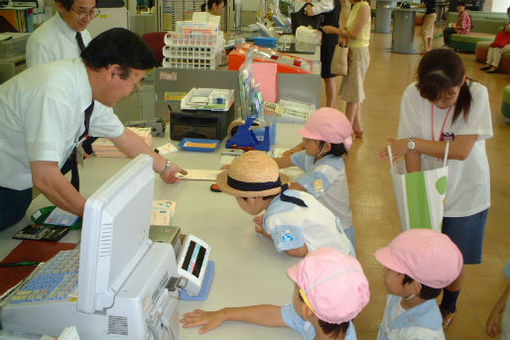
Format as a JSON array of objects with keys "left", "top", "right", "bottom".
[{"left": 287, "top": 248, "right": 370, "bottom": 324}]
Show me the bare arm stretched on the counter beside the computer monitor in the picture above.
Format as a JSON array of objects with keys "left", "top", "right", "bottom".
[{"left": 180, "top": 305, "right": 287, "bottom": 333}]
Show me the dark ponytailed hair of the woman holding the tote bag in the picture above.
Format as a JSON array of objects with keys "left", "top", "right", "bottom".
[{"left": 416, "top": 48, "right": 472, "bottom": 123}]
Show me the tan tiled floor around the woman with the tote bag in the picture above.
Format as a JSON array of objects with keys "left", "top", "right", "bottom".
[{"left": 323, "top": 25, "right": 510, "bottom": 340}]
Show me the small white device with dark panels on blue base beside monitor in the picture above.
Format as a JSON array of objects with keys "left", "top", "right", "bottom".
[{"left": 177, "top": 234, "right": 214, "bottom": 299}]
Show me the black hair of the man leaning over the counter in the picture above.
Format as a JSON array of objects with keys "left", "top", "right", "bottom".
[{"left": 81, "top": 28, "right": 158, "bottom": 77}]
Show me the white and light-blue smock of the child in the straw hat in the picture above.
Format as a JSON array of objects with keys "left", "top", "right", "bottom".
[{"left": 264, "top": 189, "right": 354, "bottom": 256}]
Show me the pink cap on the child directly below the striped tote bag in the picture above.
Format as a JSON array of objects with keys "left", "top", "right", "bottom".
[{"left": 375, "top": 229, "right": 463, "bottom": 288}]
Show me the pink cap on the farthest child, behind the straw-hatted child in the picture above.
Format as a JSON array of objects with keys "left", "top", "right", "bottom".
[{"left": 299, "top": 107, "right": 352, "bottom": 150}]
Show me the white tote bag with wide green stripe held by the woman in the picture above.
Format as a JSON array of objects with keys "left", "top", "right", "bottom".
[{"left": 388, "top": 143, "right": 450, "bottom": 231}]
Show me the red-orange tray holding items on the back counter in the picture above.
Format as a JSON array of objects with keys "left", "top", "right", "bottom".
[{"left": 228, "top": 44, "right": 313, "bottom": 74}]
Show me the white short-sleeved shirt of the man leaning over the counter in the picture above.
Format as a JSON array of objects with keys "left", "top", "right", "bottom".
[{"left": 0, "top": 59, "right": 124, "bottom": 190}]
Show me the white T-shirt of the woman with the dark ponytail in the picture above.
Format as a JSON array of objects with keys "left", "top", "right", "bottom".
[{"left": 398, "top": 80, "right": 492, "bottom": 217}]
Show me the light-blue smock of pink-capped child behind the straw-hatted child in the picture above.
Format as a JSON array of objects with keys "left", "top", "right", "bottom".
[{"left": 290, "top": 150, "right": 354, "bottom": 238}]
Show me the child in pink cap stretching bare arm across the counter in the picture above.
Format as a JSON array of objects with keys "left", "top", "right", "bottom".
[{"left": 181, "top": 248, "right": 370, "bottom": 340}]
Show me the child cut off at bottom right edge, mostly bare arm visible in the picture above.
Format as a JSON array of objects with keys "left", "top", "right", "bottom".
[{"left": 487, "top": 260, "right": 510, "bottom": 340}]
